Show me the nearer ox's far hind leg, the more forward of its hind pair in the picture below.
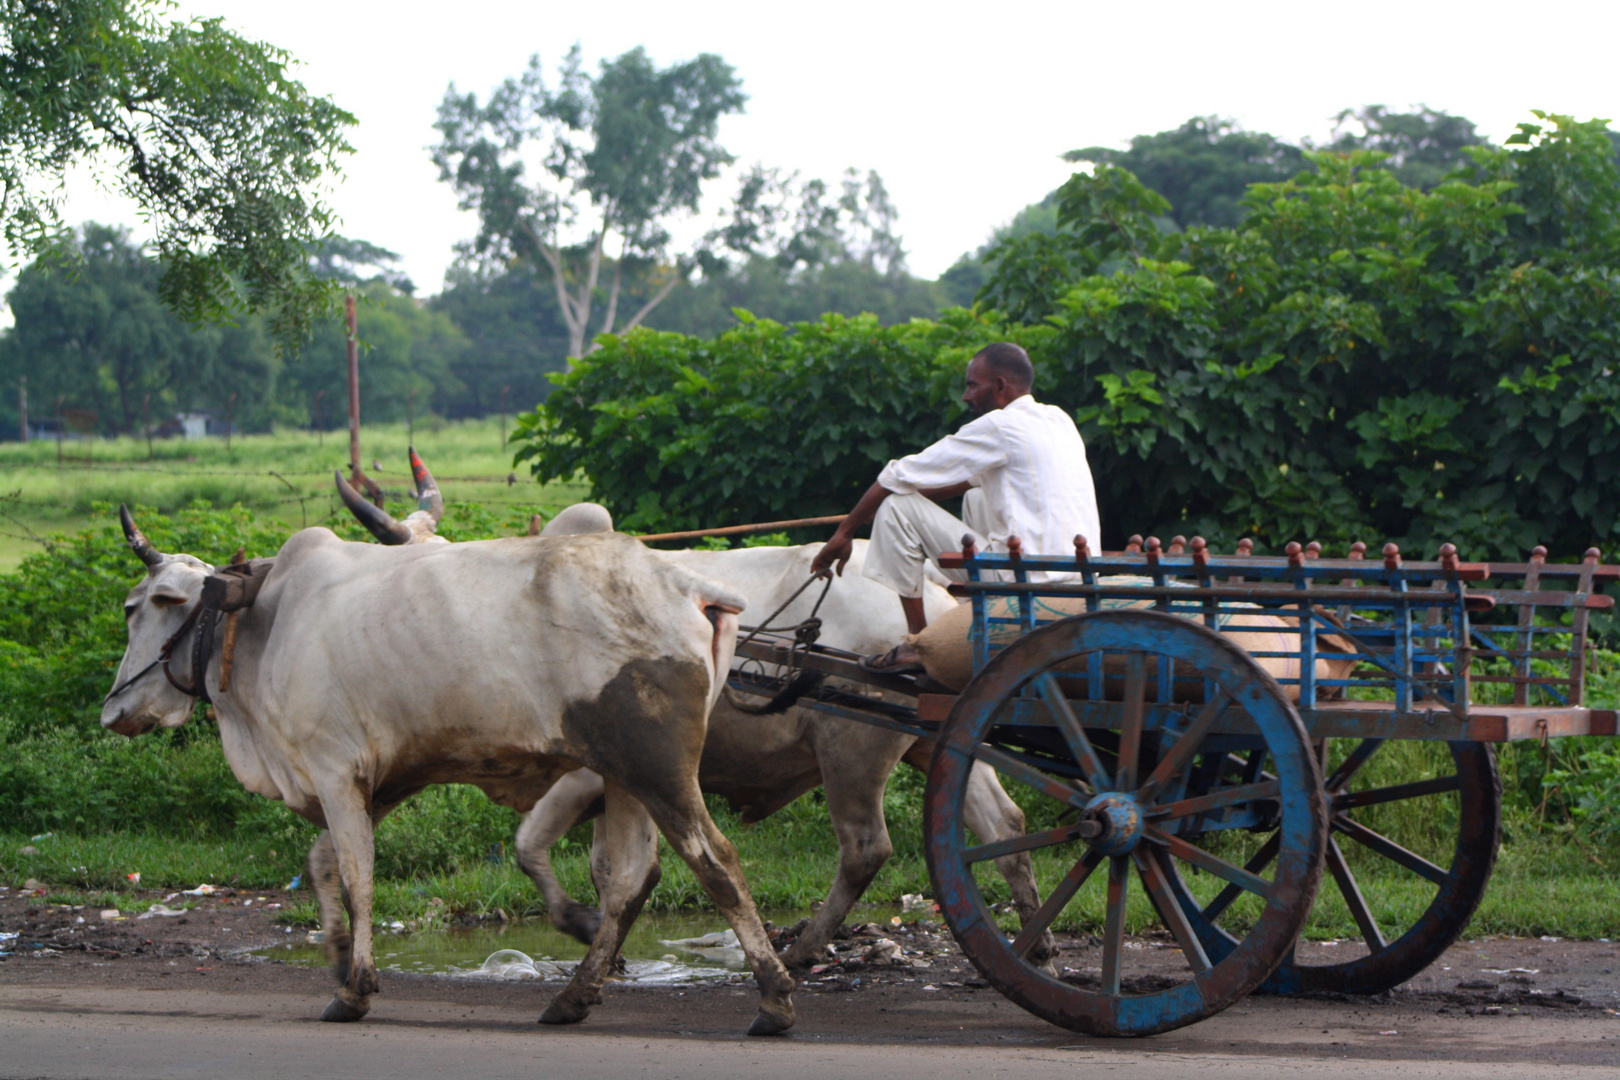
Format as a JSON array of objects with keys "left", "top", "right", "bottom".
[{"left": 539, "top": 784, "right": 659, "bottom": 1023}]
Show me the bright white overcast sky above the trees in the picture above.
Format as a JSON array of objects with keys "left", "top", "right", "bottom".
[{"left": 44, "top": 0, "right": 1620, "bottom": 293}]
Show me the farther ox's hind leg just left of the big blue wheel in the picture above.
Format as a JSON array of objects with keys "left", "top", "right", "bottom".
[{"left": 782, "top": 740, "right": 901, "bottom": 968}]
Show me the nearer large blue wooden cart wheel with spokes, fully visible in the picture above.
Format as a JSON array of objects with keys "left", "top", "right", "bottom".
[{"left": 923, "top": 610, "right": 1327, "bottom": 1035}]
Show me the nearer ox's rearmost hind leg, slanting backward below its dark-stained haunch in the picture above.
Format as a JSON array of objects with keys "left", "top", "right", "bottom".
[{"left": 648, "top": 779, "right": 794, "bottom": 1035}]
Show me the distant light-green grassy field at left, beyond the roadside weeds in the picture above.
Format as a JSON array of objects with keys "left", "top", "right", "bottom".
[{"left": 0, "top": 418, "right": 585, "bottom": 573}]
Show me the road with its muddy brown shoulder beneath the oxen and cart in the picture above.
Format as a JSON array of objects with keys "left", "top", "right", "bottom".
[{"left": 0, "top": 899, "right": 1620, "bottom": 1080}]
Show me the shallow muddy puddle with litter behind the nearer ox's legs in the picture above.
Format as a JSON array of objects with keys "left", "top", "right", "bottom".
[{"left": 251, "top": 912, "right": 822, "bottom": 986}]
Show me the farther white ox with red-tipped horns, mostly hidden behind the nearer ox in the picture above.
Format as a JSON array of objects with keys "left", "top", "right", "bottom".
[{"left": 339, "top": 485, "right": 1051, "bottom": 967}]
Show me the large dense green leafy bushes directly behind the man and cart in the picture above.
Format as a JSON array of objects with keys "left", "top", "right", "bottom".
[{"left": 520, "top": 113, "right": 1620, "bottom": 557}]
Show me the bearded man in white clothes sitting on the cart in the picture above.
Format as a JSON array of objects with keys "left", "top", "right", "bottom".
[{"left": 812, "top": 342, "right": 1098, "bottom": 672}]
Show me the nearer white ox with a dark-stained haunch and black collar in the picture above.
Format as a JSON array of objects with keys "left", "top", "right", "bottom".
[{"left": 102, "top": 512, "right": 794, "bottom": 1035}]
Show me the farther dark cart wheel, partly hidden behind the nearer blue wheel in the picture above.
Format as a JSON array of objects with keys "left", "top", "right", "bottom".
[{"left": 1170, "top": 738, "right": 1502, "bottom": 994}]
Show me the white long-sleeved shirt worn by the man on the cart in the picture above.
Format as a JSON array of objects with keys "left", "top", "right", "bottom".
[{"left": 878, "top": 393, "right": 1102, "bottom": 566}]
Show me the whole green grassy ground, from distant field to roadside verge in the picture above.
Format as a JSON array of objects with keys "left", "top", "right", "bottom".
[{"left": 0, "top": 421, "right": 1620, "bottom": 938}]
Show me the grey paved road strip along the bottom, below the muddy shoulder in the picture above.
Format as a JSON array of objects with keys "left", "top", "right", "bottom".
[{"left": 0, "top": 980, "right": 1620, "bottom": 1080}]
